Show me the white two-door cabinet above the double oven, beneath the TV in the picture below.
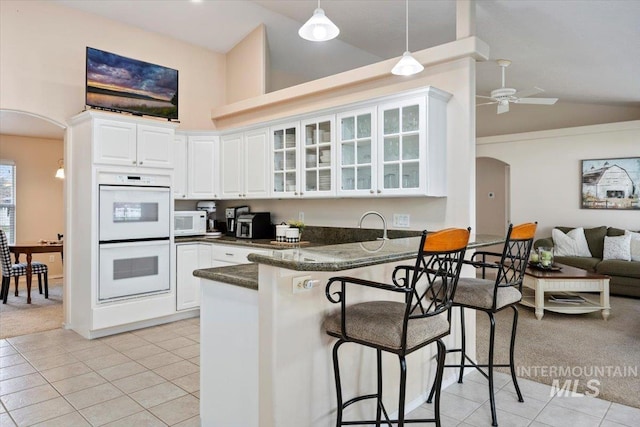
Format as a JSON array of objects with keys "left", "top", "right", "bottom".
[{"left": 93, "top": 117, "right": 174, "bottom": 169}]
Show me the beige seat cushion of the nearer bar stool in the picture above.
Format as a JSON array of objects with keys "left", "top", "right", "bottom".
[{"left": 323, "top": 301, "right": 449, "bottom": 350}]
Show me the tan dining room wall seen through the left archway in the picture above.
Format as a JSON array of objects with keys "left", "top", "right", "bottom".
[{"left": 0, "top": 135, "right": 64, "bottom": 276}]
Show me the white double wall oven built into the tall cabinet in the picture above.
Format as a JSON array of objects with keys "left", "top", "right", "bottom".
[{"left": 98, "top": 173, "right": 171, "bottom": 302}]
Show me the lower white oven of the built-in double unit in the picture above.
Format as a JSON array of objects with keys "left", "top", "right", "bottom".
[{"left": 98, "top": 240, "right": 171, "bottom": 302}]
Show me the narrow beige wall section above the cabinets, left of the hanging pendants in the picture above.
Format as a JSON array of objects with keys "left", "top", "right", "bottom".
[{"left": 226, "top": 25, "right": 267, "bottom": 104}]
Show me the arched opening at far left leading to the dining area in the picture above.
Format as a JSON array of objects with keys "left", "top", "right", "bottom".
[{"left": 0, "top": 109, "right": 67, "bottom": 336}]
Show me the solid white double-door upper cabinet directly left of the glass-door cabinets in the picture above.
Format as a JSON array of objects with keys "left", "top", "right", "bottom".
[{"left": 220, "top": 128, "right": 270, "bottom": 199}]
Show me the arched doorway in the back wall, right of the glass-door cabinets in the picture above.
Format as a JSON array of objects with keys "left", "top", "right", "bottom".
[{"left": 476, "top": 157, "right": 511, "bottom": 236}]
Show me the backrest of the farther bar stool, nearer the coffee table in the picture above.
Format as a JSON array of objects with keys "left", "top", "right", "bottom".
[{"left": 494, "top": 222, "right": 537, "bottom": 290}]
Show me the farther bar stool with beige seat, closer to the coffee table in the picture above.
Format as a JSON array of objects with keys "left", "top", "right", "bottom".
[{"left": 427, "top": 223, "right": 537, "bottom": 426}]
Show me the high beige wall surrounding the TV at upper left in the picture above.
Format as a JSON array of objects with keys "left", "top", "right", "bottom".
[{"left": 0, "top": 0, "right": 225, "bottom": 130}]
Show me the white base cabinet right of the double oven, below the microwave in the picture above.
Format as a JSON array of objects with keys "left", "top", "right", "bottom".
[{"left": 176, "top": 243, "right": 212, "bottom": 310}]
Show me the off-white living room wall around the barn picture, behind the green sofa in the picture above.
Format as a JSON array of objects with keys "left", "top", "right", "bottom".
[{"left": 476, "top": 120, "right": 640, "bottom": 237}]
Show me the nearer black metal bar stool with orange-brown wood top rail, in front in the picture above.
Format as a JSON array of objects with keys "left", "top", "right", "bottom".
[{"left": 323, "top": 228, "right": 470, "bottom": 426}]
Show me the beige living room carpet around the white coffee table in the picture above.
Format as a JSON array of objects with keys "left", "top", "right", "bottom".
[{"left": 476, "top": 296, "right": 640, "bottom": 408}]
